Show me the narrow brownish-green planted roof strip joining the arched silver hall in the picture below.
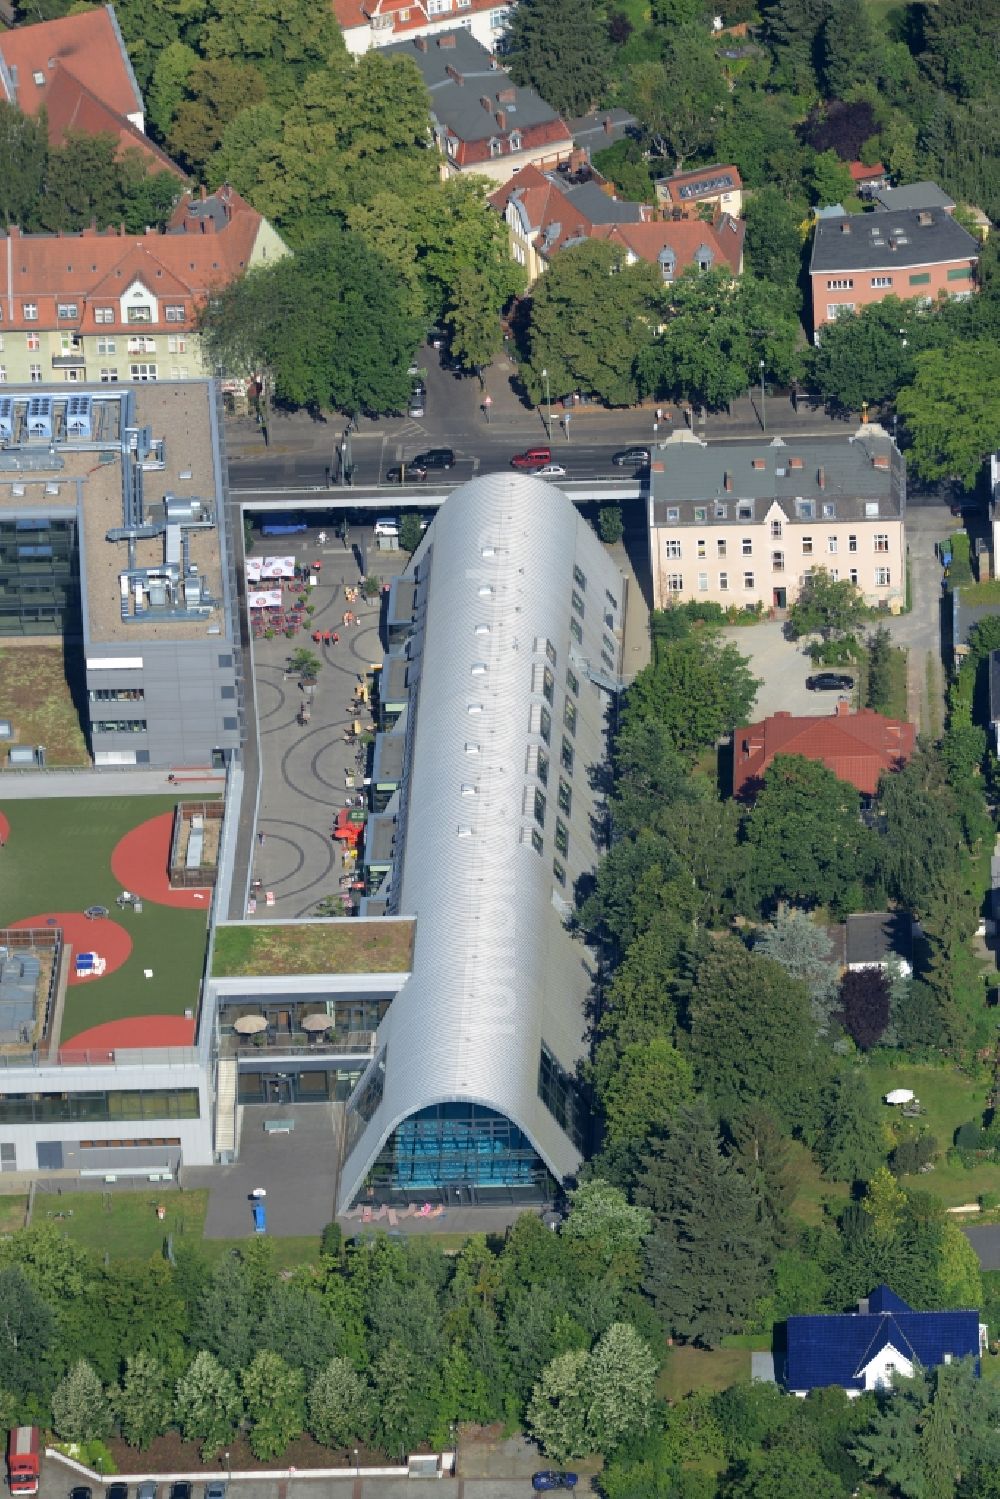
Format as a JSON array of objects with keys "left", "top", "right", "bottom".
[{"left": 211, "top": 917, "right": 415, "bottom": 979}]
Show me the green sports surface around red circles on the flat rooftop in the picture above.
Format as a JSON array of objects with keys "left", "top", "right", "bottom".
[{"left": 0, "top": 796, "right": 207, "bottom": 1042}]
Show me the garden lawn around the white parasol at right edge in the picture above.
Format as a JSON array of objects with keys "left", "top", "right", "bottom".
[{"left": 870, "top": 1064, "right": 1000, "bottom": 1207}]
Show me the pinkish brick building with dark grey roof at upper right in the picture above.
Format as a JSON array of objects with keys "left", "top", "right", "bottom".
[{"left": 810, "top": 200, "right": 979, "bottom": 339}]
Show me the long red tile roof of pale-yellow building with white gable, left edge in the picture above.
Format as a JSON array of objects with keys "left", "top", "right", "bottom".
[{"left": 0, "top": 187, "right": 269, "bottom": 333}]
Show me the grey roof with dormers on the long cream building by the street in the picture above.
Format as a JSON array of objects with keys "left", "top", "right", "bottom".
[{"left": 651, "top": 424, "right": 906, "bottom": 525}]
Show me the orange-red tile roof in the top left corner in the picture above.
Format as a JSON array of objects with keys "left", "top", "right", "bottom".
[{"left": 0, "top": 6, "right": 142, "bottom": 115}]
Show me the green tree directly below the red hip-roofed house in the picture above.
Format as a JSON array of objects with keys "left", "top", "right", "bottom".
[{"left": 745, "top": 755, "right": 876, "bottom": 910}]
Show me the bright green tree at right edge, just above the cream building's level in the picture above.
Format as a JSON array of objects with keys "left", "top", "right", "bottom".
[{"left": 897, "top": 339, "right": 1000, "bottom": 489}]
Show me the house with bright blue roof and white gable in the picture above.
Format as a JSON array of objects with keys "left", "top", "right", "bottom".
[{"left": 784, "top": 1286, "right": 987, "bottom": 1397}]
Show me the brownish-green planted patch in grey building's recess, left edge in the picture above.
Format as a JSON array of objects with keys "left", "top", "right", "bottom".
[{"left": 0, "top": 640, "right": 90, "bottom": 766}]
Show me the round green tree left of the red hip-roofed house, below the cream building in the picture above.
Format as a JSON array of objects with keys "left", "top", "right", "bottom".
[{"left": 622, "top": 633, "right": 760, "bottom": 757}]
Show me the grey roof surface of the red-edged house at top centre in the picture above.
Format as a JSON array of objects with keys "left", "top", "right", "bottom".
[{"left": 382, "top": 27, "right": 559, "bottom": 141}]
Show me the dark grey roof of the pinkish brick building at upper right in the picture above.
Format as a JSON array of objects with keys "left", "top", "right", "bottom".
[{"left": 810, "top": 208, "right": 979, "bottom": 273}]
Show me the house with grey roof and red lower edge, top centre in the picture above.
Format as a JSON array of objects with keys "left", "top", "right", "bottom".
[{"left": 387, "top": 30, "right": 573, "bottom": 181}]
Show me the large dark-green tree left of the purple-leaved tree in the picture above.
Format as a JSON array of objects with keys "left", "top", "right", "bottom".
[{"left": 689, "top": 937, "right": 816, "bottom": 1130}]
